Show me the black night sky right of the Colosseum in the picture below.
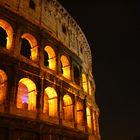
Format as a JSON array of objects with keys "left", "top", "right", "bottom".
[{"left": 59, "top": 0, "right": 140, "bottom": 140}]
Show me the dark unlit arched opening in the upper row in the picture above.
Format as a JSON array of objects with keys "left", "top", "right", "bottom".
[{"left": 73, "top": 66, "right": 80, "bottom": 85}]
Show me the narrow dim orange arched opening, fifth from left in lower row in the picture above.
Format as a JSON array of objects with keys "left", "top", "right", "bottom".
[{"left": 76, "top": 101, "right": 84, "bottom": 125}]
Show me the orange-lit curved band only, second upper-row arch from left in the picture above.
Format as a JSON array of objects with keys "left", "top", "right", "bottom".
[{"left": 21, "top": 33, "right": 38, "bottom": 61}]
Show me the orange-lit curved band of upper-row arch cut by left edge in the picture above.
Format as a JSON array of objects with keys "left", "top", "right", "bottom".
[{"left": 0, "top": 19, "right": 13, "bottom": 50}]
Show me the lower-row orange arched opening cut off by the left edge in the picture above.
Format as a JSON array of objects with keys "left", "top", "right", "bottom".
[{"left": 0, "top": 69, "right": 7, "bottom": 104}]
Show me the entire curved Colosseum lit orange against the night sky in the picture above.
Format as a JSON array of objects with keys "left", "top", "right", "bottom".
[{"left": 0, "top": 0, "right": 101, "bottom": 140}]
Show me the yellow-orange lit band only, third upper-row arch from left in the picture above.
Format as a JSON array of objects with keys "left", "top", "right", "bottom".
[{"left": 44, "top": 46, "right": 56, "bottom": 70}]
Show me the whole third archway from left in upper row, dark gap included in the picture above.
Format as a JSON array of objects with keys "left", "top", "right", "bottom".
[{"left": 44, "top": 46, "right": 56, "bottom": 70}]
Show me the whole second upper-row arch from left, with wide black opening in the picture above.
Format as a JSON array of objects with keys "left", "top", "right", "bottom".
[{"left": 20, "top": 33, "right": 38, "bottom": 61}]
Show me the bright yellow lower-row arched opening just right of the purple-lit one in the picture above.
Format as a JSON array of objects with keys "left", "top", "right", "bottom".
[{"left": 43, "top": 87, "right": 58, "bottom": 117}]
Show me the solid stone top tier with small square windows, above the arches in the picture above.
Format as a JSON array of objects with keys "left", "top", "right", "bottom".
[{"left": 0, "top": 0, "right": 92, "bottom": 73}]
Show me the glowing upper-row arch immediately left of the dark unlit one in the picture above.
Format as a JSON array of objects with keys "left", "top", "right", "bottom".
[{"left": 61, "top": 55, "right": 70, "bottom": 79}]
